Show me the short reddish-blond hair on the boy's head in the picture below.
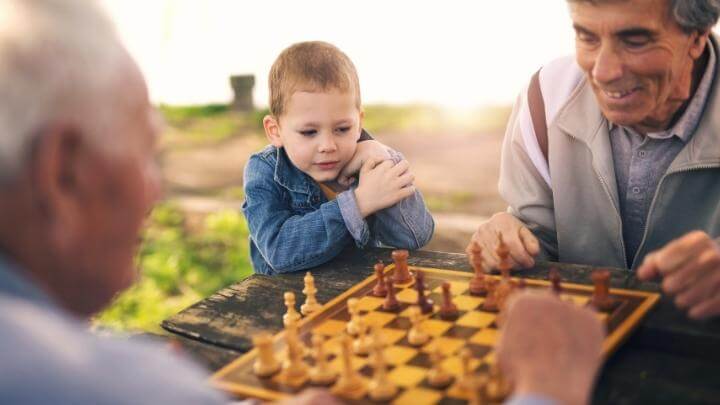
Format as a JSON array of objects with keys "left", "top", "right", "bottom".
[{"left": 268, "top": 41, "right": 360, "bottom": 117}]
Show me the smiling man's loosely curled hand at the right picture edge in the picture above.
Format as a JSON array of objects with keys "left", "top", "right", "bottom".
[{"left": 637, "top": 231, "right": 720, "bottom": 319}]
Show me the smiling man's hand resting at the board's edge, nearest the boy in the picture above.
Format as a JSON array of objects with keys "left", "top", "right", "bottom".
[{"left": 470, "top": 212, "right": 540, "bottom": 268}]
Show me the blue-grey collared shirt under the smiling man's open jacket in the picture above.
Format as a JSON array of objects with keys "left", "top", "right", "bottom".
[{"left": 609, "top": 45, "right": 716, "bottom": 267}]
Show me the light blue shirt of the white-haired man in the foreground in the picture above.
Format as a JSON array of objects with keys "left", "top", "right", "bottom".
[{"left": 0, "top": 256, "right": 227, "bottom": 404}]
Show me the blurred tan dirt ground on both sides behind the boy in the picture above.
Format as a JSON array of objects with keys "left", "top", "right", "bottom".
[{"left": 161, "top": 129, "right": 505, "bottom": 252}]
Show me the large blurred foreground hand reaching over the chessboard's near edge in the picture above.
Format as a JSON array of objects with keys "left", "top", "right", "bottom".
[{"left": 497, "top": 292, "right": 604, "bottom": 404}]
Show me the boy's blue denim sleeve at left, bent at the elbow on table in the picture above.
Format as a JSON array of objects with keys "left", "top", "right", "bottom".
[{"left": 243, "top": 156, "right": 352, "bottom": 273}]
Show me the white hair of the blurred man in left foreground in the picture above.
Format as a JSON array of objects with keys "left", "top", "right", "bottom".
[{"left": 0, "top": 0, "right": 125, "bottom": 184}]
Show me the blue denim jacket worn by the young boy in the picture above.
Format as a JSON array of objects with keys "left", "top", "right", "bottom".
[{"left": 242, "top": 145, "right": 435, "bottom": 274}]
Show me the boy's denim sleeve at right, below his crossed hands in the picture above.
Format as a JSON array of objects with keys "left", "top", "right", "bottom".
[{"left": 370, "top": 150, "right": 435, "bottom": 250}]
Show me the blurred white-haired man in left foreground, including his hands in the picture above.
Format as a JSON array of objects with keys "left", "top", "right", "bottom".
[{"left": 0, "top": 0, "right": 602, "bottom": 404}]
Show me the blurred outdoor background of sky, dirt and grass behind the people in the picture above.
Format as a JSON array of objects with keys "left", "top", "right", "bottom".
[{"left": 96, "top": 0, "right": 574, "bottom": 332}]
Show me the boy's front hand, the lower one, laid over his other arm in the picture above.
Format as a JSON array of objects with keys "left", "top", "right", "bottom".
[{"left": 354, "top": 157, "right": 415, "bottom": 218}]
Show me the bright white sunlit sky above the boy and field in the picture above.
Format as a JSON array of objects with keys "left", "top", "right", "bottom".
[{"left": 103, "top": 0, "right": 573, "bottom": 108}]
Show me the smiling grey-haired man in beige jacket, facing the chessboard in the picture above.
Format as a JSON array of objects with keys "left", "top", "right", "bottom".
[{"left": 473, "top": 0, "right": 720, "bottom": 318}]
